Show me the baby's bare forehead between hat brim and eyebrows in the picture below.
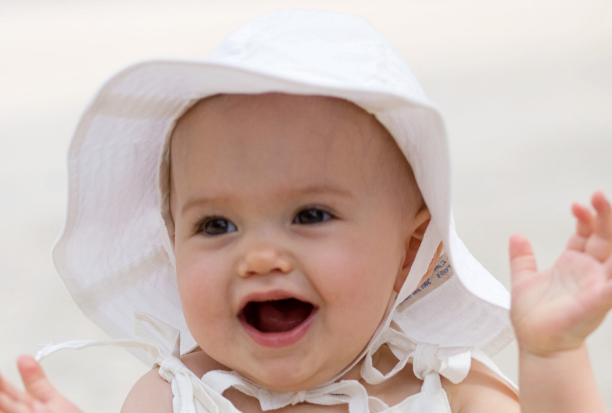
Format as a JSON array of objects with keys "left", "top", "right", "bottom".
[{"left": 171, "top": 93, "right": 405, "bottom": 203}]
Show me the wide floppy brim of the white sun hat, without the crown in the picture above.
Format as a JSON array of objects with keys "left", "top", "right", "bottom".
[{"left": 53, "top": 61, "right": 512, "bottom": 362}]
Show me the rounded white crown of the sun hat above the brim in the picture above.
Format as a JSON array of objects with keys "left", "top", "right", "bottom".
[{"left": 207, "top": 10, "right": 428, "bottom": 103}]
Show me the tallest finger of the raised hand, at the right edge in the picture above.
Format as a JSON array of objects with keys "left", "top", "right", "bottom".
[{"left": 584, "top": 191, "right": 612, "bottom": 262}]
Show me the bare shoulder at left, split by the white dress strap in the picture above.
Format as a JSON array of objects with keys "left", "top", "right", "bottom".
[{"left": 121, "top": 351, "right": 225, "bottom": 413}]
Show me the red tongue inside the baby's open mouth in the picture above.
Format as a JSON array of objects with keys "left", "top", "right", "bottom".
[{"left": 253, "top": 298, "right": 312, "bottom": 333}]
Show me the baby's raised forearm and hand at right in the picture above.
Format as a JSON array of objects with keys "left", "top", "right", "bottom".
[{"left": 510, "top": 192, "right": 612, "bottom": 413}]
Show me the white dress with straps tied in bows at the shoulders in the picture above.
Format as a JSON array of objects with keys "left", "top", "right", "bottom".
[{"left": 36, "top": 313, "right": 516, "bottom": 413}]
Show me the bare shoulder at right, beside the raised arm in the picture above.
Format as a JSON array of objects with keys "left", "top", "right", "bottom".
[{"left": 442, "top": 360, "right": 521, "bottom": 413}]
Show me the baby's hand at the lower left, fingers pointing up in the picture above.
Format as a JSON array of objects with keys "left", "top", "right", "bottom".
[{"left": 0, "top": 356, "right": 82, "bottom": 413}]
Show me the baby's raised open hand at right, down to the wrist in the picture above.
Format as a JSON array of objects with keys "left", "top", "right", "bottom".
[{"left": 510, "top": 192, "right": 612, "bottom": 356}]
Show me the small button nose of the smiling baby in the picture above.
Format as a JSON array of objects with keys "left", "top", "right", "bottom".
[{"left": 238, "top": 244, "right": 293, "bottom": 278}]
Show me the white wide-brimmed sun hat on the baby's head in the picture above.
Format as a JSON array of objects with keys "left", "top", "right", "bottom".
[{"left": 53, "top": 10, "right": 513, "bottom": 370}]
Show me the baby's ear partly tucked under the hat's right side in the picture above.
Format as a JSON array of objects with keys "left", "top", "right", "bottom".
[{"left": 393, "top": 208, "right": 442, "bottom": 294}]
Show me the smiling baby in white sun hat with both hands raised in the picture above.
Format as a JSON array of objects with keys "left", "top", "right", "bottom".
[{"left": 0, "top": 11, "right": 612, "bottom": 413}]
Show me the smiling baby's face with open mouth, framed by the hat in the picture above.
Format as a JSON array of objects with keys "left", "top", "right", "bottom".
[{"left": 171, "top": 94, "right": 428, "bottom": 391}]
